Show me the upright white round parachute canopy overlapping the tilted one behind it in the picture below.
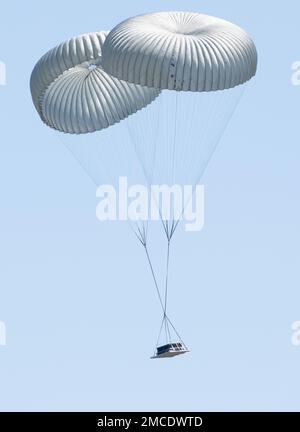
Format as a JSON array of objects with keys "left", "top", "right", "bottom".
[{"left": 103, "top": 12, "right": 257, "bottom": 91}]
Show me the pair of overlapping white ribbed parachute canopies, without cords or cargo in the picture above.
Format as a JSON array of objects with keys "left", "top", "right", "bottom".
[{"left": 30, "top": 12, "right": 257, "bottom": 134}]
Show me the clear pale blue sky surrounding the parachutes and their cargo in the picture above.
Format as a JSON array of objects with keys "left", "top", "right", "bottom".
[{"left": 0, "top": 0, "right": 300, "bottom": 411}]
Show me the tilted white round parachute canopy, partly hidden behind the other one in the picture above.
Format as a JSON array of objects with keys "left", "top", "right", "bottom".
[{"left": 30, "top": 31, "right": 159, "bottom": 134}]
